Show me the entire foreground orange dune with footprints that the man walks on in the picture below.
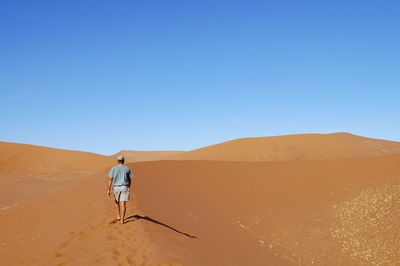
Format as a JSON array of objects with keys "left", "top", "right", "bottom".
[{"left": 0, "top": 155, "right": 400, "bottom": 265}]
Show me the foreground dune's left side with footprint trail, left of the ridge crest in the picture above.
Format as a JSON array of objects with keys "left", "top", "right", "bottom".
[{"left": 0, "top": 169, "right": 179, "bottom": 265}]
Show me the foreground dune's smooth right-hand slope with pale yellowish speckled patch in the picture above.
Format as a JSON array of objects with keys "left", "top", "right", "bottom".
[{"left": 132, "top": 155, "right": 400, "bottom": 265}]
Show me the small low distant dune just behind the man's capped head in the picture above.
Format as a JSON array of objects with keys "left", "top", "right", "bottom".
[{"left": 113, "top": 150, "right": 184, "bottom": 162}]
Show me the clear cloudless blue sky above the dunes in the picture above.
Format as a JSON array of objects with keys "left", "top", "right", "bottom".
[{"left": 0, "top": 0, "right": 400, "bottom": 154}]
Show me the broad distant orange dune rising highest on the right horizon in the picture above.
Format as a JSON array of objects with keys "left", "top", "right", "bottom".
[{"left": 168, "top": 133, "right": 400, "bottom": 161}]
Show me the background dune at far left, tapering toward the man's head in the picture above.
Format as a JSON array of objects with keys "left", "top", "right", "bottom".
[{"left": 0, "top": 142, "right": 115, "bottom": 209}]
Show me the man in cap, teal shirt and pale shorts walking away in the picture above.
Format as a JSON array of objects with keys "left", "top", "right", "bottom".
[{"left": 107, "top": 156, "right": 133, "bottom": 224}]
